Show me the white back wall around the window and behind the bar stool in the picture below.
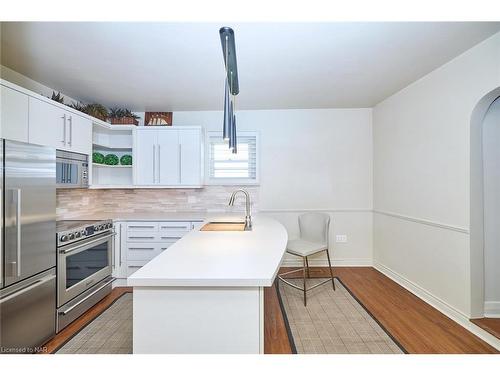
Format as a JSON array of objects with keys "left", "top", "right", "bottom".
[{"left": 173, "top": 109, "right": 373, "bottom": 265}]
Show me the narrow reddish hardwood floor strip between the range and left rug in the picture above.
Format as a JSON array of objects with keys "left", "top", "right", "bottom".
[{"left": 41, "top": 287, "right": 132, "bottom": 354}]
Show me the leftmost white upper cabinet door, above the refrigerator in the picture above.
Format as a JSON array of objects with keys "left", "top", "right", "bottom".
[{"left": 0, "top": 85, "right": 29, "bottom": 142}]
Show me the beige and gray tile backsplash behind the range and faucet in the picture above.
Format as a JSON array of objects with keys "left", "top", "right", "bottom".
[{"left": 57, "top": 186, "right": 259, "bottom": 220}]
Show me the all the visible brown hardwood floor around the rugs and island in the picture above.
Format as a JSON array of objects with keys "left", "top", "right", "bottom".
[{"left": 45, "top": 267, "right": 500, "bottom": 354}]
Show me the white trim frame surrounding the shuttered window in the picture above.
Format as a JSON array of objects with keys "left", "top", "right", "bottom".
[{"left": 205, "top": 130, "right": 260, "bottom": 186}]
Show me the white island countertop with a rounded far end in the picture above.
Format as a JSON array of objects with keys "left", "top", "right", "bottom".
[{"left": 127, "top": 216, "right": 288, "bottom": 287}]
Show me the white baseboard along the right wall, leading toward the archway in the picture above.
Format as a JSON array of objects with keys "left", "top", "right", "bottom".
[{"left": 373, "top": 260, "right": 500, "bottom": 350}]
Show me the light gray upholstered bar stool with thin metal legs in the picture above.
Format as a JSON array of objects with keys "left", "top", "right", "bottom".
[{"left": 278, "top": 212, "right": 335, "bottom": 306}]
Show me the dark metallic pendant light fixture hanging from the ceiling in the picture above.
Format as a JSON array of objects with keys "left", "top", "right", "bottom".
[{"left": 219, "top": 27, "right": 239, "bottom": 154}]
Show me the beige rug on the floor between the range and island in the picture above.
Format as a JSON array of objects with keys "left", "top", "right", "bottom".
[{"left": 56, "top": 293, "right": 132, "bottom": 354}]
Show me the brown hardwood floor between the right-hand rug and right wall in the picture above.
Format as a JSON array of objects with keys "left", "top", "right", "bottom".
[{"left": 272, "top": 267, "right": 498, "bottom": 354}]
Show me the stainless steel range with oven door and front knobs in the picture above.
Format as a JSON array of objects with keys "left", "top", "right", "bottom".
[{"left": 57, "top": 220, "right": 115, "bottom": 332}]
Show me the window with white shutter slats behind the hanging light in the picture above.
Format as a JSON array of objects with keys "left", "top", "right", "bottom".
[{"left": 207, "top": 132, "right": 258, "bottom": 185}]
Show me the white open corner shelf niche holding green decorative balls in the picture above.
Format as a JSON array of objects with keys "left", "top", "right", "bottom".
[{"left": 90, "top": 123, "right": 135, "bottom": 189}]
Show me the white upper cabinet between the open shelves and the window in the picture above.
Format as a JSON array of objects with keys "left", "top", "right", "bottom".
[{"left": 133, "top": 126, "right": 203, "bottom": 187}]
